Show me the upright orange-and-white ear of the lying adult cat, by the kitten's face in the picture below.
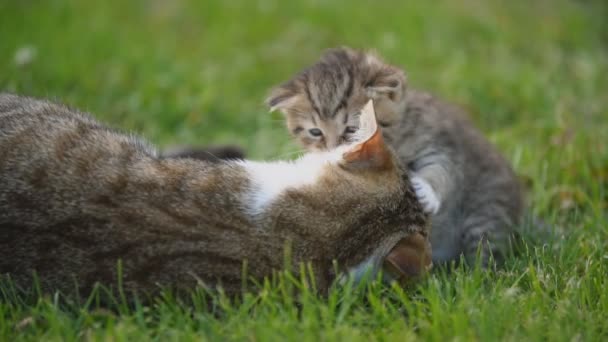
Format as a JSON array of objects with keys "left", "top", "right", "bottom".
[{"left": 343, "top": 100, "right": 392, "bottom": 169}]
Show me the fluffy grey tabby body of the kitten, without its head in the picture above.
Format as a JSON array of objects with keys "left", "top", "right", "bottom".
[{"left": 383, "top": 90, "right": 522, "bottom": 265}]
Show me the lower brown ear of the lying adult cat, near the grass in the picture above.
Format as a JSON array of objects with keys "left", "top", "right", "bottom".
[{"left": 382, "top": 233, "right": 433, "bottom": 284}]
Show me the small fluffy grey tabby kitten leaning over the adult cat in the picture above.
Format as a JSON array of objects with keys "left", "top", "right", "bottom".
[{"left": 266, "top": 48, "right": 522, "bottom": 266}]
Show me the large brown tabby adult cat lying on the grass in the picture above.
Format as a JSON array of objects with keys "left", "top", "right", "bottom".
[{"left": 0, "top": 94, "right": 430, "bottom": 295}]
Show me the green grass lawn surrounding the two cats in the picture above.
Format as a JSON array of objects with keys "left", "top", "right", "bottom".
[{"left": 0, "top": 0, "right": 608, "bottom": 341}]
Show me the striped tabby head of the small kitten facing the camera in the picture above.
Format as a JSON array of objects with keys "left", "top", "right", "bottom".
[{"left": 266, "top": 47, "right": 407, "bottom": 150}]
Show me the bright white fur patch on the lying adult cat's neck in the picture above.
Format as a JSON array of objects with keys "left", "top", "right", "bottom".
[{"left": 239, "top": 149, "right": 343, "bottom": 214}]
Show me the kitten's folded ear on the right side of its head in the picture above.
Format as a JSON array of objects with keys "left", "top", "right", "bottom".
[{"left": 365, "top": 55, "right": 407, "bottom": 102}]
